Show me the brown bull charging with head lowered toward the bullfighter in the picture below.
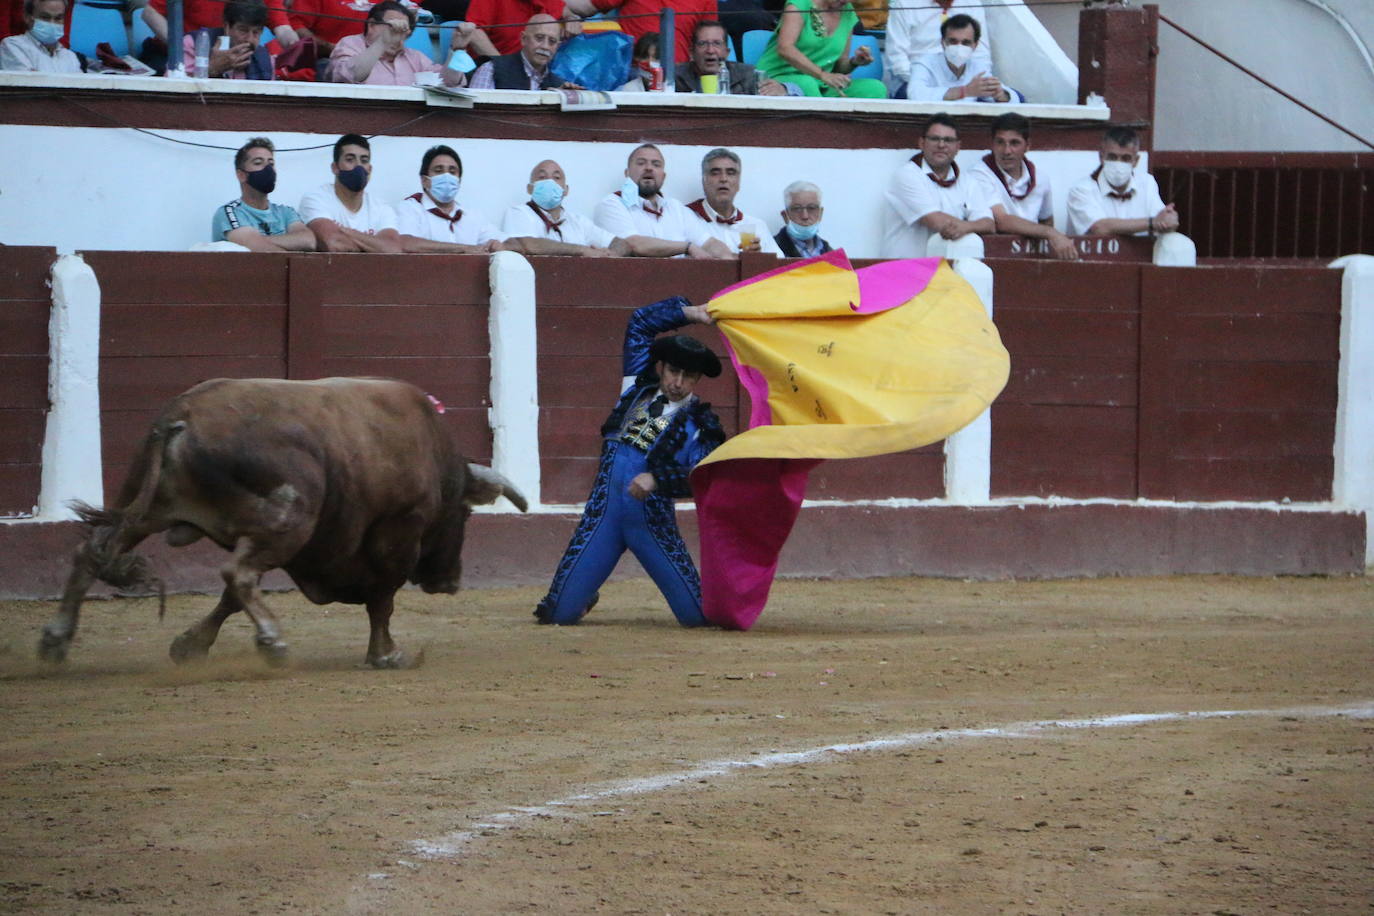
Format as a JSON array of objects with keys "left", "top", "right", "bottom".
[{"left": 38, "top": 379, "right": 526, "bottom": 667}]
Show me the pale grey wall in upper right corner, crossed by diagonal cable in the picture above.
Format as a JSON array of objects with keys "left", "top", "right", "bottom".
[{"left": 1035, "top": 0, "right": 1374, "bottom": 151}]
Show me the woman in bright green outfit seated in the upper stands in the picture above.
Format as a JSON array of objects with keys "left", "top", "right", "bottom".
[{"left": 757, "top": 0, "right": 888, "bottom": 99}]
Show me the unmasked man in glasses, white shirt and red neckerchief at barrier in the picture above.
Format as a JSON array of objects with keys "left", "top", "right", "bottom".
[{"left": 882, "top": 113, "right": 995, "bottom": 258}]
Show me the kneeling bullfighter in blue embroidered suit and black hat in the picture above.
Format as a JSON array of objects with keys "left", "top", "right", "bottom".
[{"left": 534, "top": 295, "right": 725, "bottom": 626}]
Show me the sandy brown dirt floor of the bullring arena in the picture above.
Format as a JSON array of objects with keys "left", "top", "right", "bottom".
[{"left": 0, "top": 578, "right": 1374, "bottom": 915}]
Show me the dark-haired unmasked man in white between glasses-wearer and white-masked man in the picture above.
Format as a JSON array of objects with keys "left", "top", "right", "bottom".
[{"left": 971, "top": 111, "right": 1079, "bottom": 261}]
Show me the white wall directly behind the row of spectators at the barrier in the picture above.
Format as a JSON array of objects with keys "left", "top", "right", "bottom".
[{"left": 0, "top": 125, "right": 1096, "bottom": 257}]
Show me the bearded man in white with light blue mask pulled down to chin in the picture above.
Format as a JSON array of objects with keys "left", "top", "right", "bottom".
[{"left": 595, "top": 143, "right": 735, "bottom": 258}]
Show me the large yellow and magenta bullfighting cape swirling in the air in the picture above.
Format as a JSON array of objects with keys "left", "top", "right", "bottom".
[{"left": 691, "top": 251, "right": 1010, "bottom": 629}]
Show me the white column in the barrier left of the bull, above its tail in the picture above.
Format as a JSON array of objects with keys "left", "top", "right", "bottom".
[{"left": 34, "top": 254, "right": 104, "bottom": 522}]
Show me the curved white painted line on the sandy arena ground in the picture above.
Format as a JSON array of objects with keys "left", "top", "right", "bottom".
[{"left": 401, "top": 702, "right": 1374, "bottom": 862}]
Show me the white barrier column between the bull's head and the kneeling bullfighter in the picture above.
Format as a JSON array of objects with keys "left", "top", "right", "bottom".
[{"left": 486, "top": 251, "right": 540, "bottom": 512}]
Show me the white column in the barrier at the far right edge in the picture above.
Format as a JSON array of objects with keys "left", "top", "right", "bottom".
[{"left": 1331, "top": 254, "right": 1374, "bottom": 571}]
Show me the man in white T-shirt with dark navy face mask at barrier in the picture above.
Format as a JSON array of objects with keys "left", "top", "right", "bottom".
[{"left": 301, "top": 134, "right": 401, "bottom": 253}]
